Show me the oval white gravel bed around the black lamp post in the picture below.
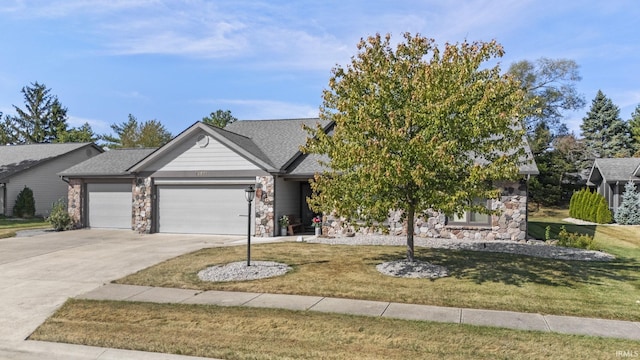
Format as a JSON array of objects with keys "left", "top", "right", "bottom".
[{"left": 198, "top": 261, "right": 291, "bottom": 282}]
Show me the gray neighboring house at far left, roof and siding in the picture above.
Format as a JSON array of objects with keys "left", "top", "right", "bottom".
[{"left": 0, "top": 143, "right": 102, "bottom": 216}]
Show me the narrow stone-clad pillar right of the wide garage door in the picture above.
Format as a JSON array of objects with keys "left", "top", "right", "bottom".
[{"left": 253, "top": 176, "right": 275, "bottom": 236}]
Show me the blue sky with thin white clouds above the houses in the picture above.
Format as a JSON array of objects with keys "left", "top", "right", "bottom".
[{"left": 0, "top": 0, "right": 640, "bottom": 135}]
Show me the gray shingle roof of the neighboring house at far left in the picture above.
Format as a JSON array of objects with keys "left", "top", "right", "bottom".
[{"left": 0, "top": 143, "right": 93, "bottom": 179}]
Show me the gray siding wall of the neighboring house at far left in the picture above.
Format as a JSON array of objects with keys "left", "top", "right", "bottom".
[{"left": 5, "top": 146, "right": 99, "bottom": 216}]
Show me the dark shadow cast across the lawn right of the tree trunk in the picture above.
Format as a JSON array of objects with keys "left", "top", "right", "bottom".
[{"left": 372, "top": 248, "right": 640, "bottom": 288}]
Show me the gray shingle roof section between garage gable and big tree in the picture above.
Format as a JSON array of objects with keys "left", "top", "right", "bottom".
[{"left": 225, "top": 118, "right": 329, "bottom": 169}]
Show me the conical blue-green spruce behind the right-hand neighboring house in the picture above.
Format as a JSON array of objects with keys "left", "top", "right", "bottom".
[{"left": 580, "top": 90, "right": 633, "bottom": 159}]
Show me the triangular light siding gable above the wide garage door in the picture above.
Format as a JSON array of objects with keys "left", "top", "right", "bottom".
[{"left": 146, "top": 132, "right": 260, "bottom": 171}]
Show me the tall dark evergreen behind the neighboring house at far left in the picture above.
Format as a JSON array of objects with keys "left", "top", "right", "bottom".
[{"left": 3, "top": 82, "right": 67, "bottom": 144}]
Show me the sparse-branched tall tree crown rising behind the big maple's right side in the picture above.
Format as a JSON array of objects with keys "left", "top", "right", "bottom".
[{"left": 508, "top": 58, "right": 585, "bottom": 133}]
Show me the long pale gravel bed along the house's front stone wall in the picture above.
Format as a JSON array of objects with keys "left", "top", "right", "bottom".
[{"left": 306, "top": 235, "right": 615, "bottom": 261}]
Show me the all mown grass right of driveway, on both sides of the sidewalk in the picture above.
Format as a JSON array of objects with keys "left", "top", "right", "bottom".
[{"left": 30, "top": 210, "right": 640, "bottom": 359}]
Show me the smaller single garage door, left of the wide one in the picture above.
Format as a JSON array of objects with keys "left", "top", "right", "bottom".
[{"left": 87, "top": 184, "right": 132, "bottom": 229}]
